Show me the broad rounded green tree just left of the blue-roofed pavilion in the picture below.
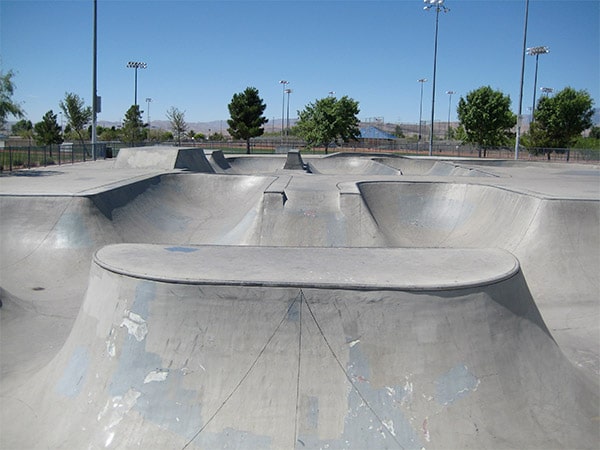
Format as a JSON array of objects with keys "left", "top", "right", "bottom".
[{"left": 294, "top": 96, "right": 360, "bottom": 153}]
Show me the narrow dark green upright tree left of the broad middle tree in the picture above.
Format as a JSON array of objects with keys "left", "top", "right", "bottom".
[{"left": 227, "top": 87, "right": 269, "bottom": 153}]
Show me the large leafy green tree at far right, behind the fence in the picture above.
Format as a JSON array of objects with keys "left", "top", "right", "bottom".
[{"left": 529, "top": 87, "right": 594, "bottom": 159}]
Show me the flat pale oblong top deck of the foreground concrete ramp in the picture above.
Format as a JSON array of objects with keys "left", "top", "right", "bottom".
[{"left": 94, "top": 244, "right": 520, "bottom": 291}]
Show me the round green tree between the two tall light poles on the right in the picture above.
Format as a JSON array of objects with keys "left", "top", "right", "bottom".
[{"left": 457, "top": 86, "right": 517, "bottom": 157}]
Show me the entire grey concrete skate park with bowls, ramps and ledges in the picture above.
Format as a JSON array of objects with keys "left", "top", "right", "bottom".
[{"left": 0, "top": 147, "right": 600, "bottom": 449}]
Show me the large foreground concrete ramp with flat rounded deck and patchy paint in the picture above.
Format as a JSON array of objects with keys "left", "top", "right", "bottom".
[{"left": 2, "top": 244, "right": 599, "bottom": 449}]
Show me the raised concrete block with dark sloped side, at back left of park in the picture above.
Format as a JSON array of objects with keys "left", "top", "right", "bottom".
[{"left": 115, "top": 146, "right": 215, "bottom": 173}]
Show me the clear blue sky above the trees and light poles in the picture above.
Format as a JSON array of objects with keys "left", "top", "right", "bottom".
[{"left": 0, "top": 0, "right": 600, "bottom": 127}]
